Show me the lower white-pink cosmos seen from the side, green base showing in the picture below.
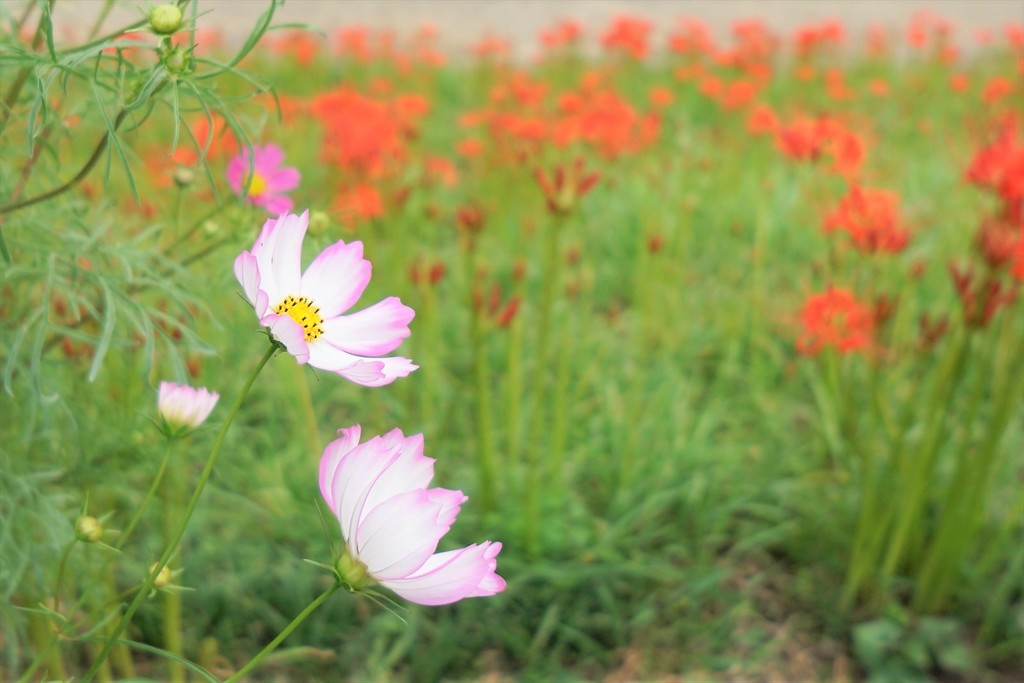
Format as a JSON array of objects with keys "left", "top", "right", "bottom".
[{"left": 319, "top": 425, "right": 505, "bottom": 605}]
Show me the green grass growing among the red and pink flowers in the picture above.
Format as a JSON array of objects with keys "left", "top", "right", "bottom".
[{"left": 0, "top": 3, "right": 1024, "bottom": 681}]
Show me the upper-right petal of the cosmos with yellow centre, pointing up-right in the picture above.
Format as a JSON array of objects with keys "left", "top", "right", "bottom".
[{"left": 299, "top": 242, "right": 372, "bottom": 318}]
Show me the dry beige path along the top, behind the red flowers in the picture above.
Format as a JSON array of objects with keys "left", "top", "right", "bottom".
[{"left": 12, "top": 0, "right": 1024, "bottom": 58}]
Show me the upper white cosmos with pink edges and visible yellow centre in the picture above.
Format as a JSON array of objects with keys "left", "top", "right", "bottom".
[{"left": 234, "top": 211, "right": 419, "bottom": 386}]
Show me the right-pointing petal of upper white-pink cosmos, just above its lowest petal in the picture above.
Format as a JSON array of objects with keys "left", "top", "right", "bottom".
[{"left": 324, "top": 297, "right": 416, "bottom": 355}]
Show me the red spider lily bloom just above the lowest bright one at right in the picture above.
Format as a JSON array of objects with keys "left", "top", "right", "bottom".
[{"left": 824, "top": 185, "right": 910, "bottom": 254}]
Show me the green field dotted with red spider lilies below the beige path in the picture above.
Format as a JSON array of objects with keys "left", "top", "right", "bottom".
[{"left": 0, "top": 0, "right": 1024, "bottom": 683}]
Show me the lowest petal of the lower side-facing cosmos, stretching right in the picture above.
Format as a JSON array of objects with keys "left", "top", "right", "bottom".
[{"left": 381, "top": 541, "right": 505, "bottom": 605}]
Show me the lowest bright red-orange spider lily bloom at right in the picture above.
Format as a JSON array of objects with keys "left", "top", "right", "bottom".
[{"left": 797, "top": 287, "right": 874, "bottom": 355}]
